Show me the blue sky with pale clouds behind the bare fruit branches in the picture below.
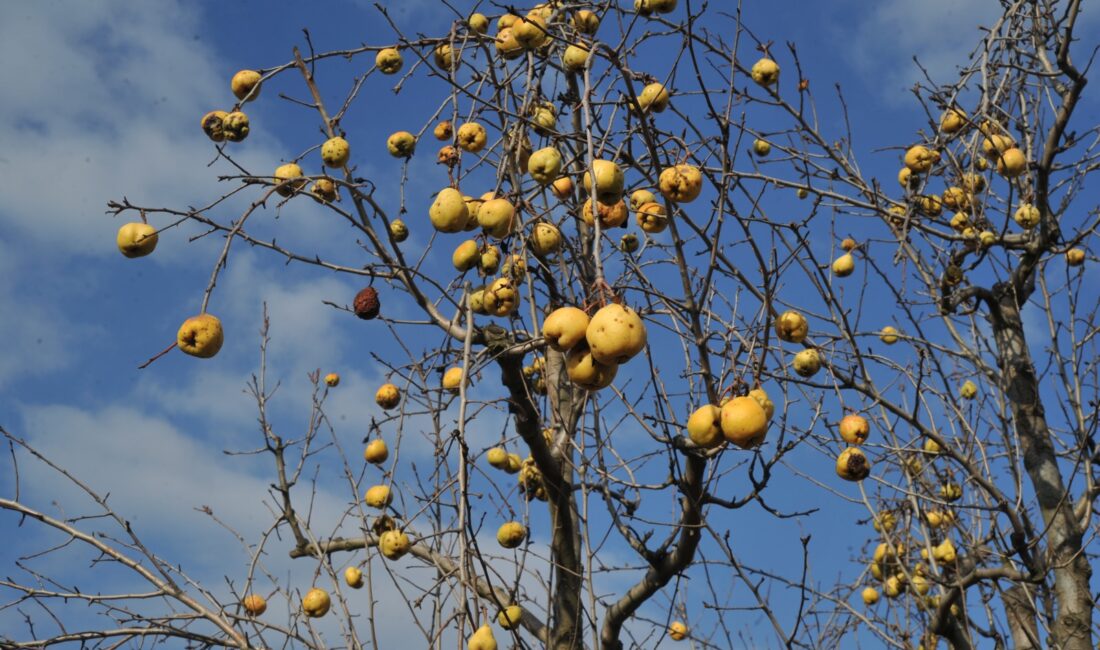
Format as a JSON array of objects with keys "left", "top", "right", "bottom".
[{"left": 0, "top": 0, "right": 1096, "bottom": 642}]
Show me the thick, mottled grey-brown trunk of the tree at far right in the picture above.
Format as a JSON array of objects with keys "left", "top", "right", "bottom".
[{"left": 990, "top": 283, "right": 1092, "bottom": 650}]
